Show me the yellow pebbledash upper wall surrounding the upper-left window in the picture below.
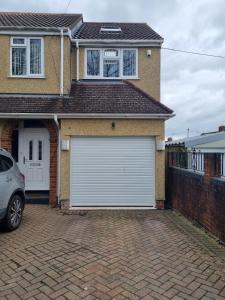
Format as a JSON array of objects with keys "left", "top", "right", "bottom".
[{"left": 0, "top": 35, "right": 72, "bottom": 94}]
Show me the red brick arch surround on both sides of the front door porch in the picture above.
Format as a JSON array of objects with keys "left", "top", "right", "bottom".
[{"left": 0, "top": 120, "right": 58, "bottom": 207}]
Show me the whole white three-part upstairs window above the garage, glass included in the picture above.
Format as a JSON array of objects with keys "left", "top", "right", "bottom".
[{"left": 85, "top": 48, "right": 138, "bottom": 79}]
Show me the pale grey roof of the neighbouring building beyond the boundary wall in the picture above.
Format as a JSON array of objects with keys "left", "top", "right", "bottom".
[{"left": 166, "top": 131, "right": 225, "bottom": 148}]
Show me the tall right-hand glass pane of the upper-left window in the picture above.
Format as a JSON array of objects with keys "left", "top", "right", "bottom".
[{"left": 30, "top": 39, "right": 42, "bottom": 74}]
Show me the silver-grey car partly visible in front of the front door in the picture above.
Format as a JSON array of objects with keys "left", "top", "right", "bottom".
[{"left": 0, "top": 149, "right": 25, "bottom": 231}]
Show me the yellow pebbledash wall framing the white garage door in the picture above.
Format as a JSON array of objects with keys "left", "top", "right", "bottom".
[{"left": 60, "top": 119, "right": 165, "bottom": 208}]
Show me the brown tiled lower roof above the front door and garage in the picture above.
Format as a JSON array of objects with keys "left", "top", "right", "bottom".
[{"left": 0, "top": 81, "right": 172, "bottom": 116}]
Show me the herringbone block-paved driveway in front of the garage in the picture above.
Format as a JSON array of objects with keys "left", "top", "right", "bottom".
[{"left": 0, "top": 205, "right": 225, "bottom": 300}]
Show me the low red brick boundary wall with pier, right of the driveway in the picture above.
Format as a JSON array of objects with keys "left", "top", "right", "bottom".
[{"left": 166, "top": 154, "right": 225, "bottom": 242}]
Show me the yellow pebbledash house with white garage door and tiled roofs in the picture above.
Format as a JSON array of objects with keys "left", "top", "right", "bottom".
[{"left": 0, "top": 12, "right": 173, "bottom": 208}]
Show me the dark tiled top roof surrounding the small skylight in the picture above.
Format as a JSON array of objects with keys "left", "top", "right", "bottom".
[{"left": 73, "top": 22, "right": 162, "bottom": 40}]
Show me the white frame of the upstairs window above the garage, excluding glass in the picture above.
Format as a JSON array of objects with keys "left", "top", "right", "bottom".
[{"left": 84, "top": 47, "right": 139, "bottom": 80}]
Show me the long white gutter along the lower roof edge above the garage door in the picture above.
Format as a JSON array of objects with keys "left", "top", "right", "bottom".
[{"left": 0, "top": 113, "right": 175, "bottom": 120}]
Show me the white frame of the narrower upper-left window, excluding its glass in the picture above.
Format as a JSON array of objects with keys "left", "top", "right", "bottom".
[{"left": 10, "top": 36, "right": 45, "bottom": 78}]
